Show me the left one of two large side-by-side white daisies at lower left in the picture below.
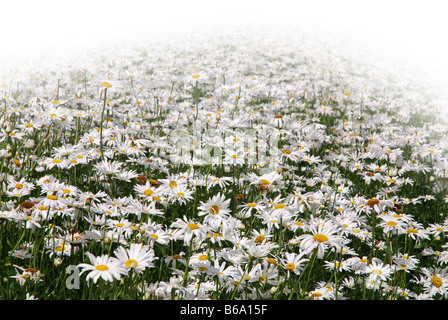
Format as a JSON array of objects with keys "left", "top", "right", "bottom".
[{"left": 77, "top": 252, "right": 128, "bottom": 283}]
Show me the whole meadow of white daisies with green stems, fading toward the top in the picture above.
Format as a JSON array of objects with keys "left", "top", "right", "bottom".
[{"left": 0, "top": 30, "right": 448, "bottom": 300}]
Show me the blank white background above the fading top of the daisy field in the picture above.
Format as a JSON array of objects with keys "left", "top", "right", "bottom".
[{"left": 0, "top": 0, "right": 448, "bottom": 90}]
